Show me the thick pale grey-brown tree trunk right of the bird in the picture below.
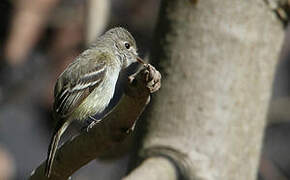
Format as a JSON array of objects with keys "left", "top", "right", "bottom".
[{"left": 127, "top": 0, "right": 284, "bottom": 180}]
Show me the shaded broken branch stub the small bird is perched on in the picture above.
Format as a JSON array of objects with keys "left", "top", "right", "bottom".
[{"left": 29, "top": 65, "right": 161, "bottom": 180}]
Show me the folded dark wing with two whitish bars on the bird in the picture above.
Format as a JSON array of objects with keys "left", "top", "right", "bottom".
[{"left": 53, "top": 51, "right": 108, "bottom": 117}]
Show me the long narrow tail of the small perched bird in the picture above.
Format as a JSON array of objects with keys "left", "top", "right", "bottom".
[{"left": 45, "top": 119, "right": 70, "bottom": 177}]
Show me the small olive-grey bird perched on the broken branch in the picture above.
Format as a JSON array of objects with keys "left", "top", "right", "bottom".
[{"left": 45, "top": 27, "right": 144, "bottom": 177}]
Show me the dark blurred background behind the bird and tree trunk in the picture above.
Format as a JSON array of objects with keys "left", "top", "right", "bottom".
[{"left": 0, "top": 0, "right": 290, "bottom": 180}]
